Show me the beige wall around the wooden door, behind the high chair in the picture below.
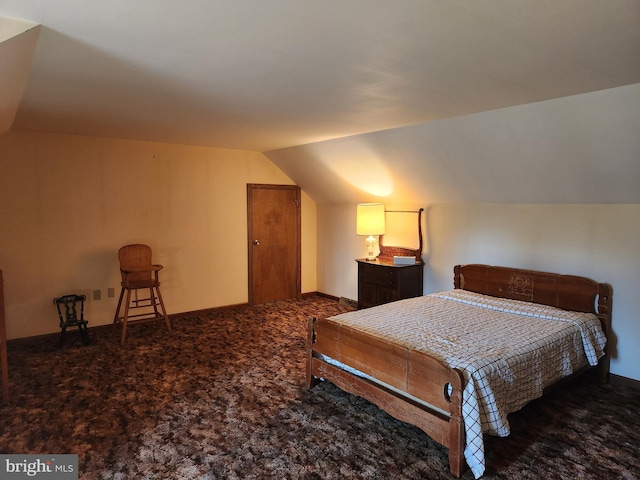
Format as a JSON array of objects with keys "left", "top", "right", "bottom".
[{"left": 0, "top": 131, "right": 317, "bottom": 338}]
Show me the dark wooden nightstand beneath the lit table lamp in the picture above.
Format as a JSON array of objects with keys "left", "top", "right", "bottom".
[{"left": 356, "top": 257, "right": 424, "bottom": 308}]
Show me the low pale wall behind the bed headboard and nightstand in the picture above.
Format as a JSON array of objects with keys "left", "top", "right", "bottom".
[{"left": 318, "top": 204, "right": 640, "bottom": 380}]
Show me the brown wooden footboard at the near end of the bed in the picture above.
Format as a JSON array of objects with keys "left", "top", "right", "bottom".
[{"left": 307, "top": 318, "right": 465, "bottom": 477}]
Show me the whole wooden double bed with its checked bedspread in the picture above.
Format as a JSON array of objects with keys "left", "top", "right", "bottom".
[{"left": 306, "top": 264, "right": 612, "bottom": 478}]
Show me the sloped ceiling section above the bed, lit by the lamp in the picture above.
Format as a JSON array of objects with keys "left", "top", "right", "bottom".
[{"left": 267, "top": 84, "right": 640, "bottom": 205}]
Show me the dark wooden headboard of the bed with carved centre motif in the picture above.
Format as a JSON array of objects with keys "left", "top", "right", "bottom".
[{"left": 453, "top": 264, "right": 613, "bottom": 381}]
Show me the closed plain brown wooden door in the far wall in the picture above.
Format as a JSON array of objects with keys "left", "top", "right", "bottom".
[{"left": 247, "top": 184, "right": 301, "bottom": 305}]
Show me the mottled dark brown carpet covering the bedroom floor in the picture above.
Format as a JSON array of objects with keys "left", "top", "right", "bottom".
[{"left": 0, "top": 298, "right": 640, "bottom": 480}]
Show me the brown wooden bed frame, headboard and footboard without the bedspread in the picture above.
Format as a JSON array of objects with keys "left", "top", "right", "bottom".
[{"left": 306, "top": 264, "right": 613, "bottom": 477}]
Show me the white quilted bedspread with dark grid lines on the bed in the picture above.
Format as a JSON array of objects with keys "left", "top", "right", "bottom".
[{"left": 331, "top": 289, "right": 606, "bottom": 478}]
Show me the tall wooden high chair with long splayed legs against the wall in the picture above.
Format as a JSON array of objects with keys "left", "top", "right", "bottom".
[{"left": 113, "top": 243, "right": 171, "bottom": 343}]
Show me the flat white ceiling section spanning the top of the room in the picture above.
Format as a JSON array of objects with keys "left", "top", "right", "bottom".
[{"left": 0, "top": 0, "right": 640, "bottom": 151}]
